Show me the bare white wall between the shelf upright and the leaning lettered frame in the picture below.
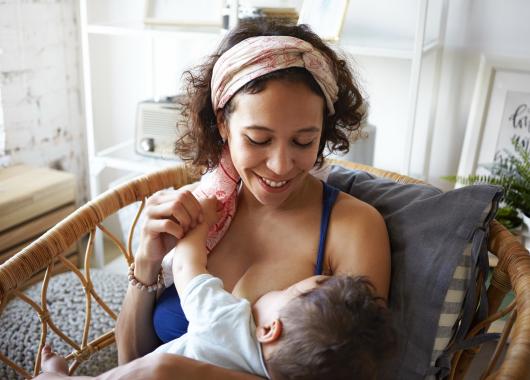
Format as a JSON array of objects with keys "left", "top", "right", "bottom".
[{"left": 429, "top": 0, "right": 530, "bottom": 188}]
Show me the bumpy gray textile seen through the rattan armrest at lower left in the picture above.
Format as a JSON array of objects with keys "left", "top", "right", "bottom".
[{"left": 0, "top": 269, "right": 128, "bottom": 379}]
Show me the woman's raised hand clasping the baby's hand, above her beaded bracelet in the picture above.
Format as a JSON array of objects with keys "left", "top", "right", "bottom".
[{"left": 135, "top": 187, "right": 204, "bottom": 283}]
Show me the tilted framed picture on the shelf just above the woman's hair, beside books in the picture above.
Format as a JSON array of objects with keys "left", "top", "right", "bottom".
[{"left": 298, "top": 0, "right": 348, "bottom": 41}]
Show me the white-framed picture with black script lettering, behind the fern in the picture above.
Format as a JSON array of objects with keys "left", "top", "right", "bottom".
[{"left": 458, "top": 55, "right": 530, "bottom": 176}]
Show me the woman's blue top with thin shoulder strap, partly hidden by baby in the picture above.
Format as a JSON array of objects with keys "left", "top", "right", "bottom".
[{"left": 153, "top": 182, "right": 339, "bottom": 343}]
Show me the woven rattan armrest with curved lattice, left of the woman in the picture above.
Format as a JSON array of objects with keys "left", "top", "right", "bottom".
[{"left": 0, "top": 165, "right": 196, "bottom": 378}]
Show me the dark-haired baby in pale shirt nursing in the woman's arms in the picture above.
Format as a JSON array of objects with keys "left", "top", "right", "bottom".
[{"left": 42, "top": 199, "right": 395, "bottom": 379}]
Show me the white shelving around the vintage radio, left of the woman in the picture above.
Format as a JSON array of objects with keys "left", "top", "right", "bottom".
[{"left": 79, "top": 0, "right": 229, "bottom": 266}]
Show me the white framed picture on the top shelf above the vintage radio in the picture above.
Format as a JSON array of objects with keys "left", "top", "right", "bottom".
[{"left": 144, "top": 0, "right": 226, "bottom": 27}]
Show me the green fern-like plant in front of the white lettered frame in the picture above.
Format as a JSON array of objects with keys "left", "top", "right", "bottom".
[{"left": 451, "top": 139, "right": 530, "bottom": 231}]
